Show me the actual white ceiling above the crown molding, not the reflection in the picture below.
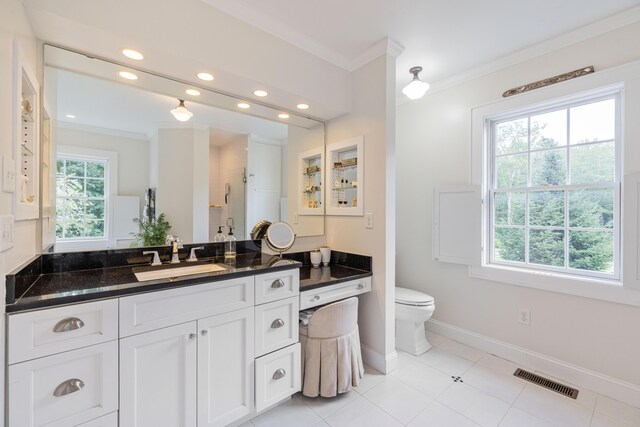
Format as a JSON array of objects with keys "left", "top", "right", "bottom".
[{"left": 203, "top": 0, "right": 640, "bottom": 98}]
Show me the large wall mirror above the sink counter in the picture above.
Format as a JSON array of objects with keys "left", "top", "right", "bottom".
[{"left": 41, "top": 45, "right": 325, "bottom": 252}]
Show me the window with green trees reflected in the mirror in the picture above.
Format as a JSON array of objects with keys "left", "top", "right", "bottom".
[{"left": 56, "top": 156, "right": 108, "bottom": 240}]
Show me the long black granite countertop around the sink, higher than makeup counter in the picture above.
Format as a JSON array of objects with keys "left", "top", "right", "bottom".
[{"left": 6, "top": 252, "right": 301, "bottom": 313}]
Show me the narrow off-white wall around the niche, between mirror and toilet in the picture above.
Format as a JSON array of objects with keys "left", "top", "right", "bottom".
[{"left": 326, "top": 55, "right": 397, "bottom": 372}]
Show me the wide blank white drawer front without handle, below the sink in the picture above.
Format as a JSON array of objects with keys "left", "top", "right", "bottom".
[{"left": 120, "top": 276, "right": 253, "bottom": 338}]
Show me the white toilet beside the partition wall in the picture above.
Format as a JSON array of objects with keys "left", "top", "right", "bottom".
[{"left": 396, "top": 287, "right": 436, "bottom": 356}]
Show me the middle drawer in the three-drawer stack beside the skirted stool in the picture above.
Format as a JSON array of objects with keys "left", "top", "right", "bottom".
[{"left": 254, "top": 297, "right": 300, "bottom": 356}]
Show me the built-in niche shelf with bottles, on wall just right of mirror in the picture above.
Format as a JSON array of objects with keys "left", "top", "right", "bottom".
[{"left": 326, "top": 136, "right": 364, "bottom": 216}]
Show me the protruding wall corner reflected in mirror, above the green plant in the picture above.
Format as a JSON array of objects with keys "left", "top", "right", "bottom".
[{"left": 150, "top": 129, "right": 209, "bottom": 243}]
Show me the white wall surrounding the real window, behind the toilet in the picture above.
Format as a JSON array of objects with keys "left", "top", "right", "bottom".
[{"left": 396, "top": 23, "right": 640, "bottom": 385}]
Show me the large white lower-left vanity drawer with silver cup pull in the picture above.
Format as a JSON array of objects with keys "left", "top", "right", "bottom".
[{"left": 8, "top": 341, "right": 118, "bottom": 427}]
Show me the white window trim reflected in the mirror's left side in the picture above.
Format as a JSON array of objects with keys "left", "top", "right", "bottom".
[{"left": 55, "top": 145, "right": 118, "bottom": 251}]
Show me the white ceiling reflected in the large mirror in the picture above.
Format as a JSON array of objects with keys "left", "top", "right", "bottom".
[{"left": 52, "top": 68, "right": 288, "bottom": 141}]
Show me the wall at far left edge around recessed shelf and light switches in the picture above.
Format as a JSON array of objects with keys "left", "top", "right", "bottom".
[{"left": 0, "top": 0, "right": 42, "bottom": 420}]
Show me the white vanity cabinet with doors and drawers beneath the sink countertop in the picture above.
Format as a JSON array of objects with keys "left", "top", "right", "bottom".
[{"left": 7, "top": 269, "right": 301, "bottom": 427}]
